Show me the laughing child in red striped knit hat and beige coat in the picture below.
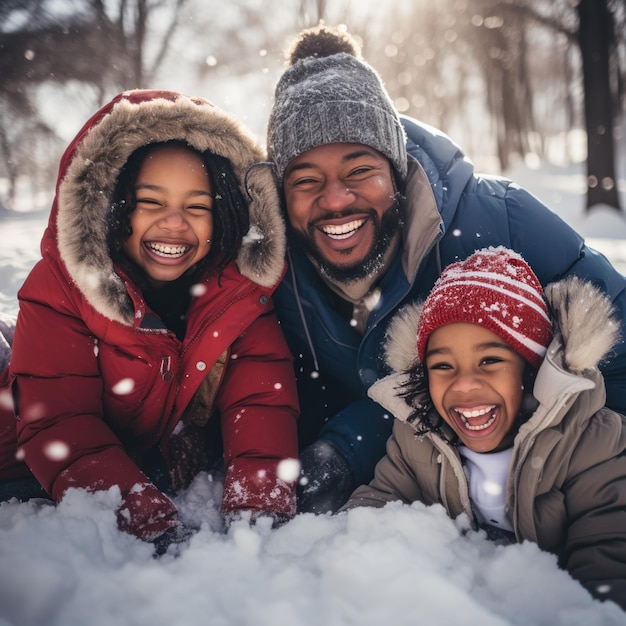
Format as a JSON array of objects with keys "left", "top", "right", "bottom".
[{"left": 344, "top": 247, "right": 626, "bottom": 607}]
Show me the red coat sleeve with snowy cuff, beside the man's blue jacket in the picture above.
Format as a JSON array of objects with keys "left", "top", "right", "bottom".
[{"left": 217, "top": 311, "right": 299, "bottom": 518}]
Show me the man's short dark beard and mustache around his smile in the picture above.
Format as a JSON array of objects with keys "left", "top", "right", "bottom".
[{"left": 291, "top": 193, "right": 403, "bottom": 284}]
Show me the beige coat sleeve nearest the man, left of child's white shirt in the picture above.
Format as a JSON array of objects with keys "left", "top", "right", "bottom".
[{"left": 341, "top": 420, "right": 432, "bottom": 511}]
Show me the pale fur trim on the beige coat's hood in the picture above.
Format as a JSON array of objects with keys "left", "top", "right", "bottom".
[{"left": 368, "top": 276, "right": 620, "bottom": 420}]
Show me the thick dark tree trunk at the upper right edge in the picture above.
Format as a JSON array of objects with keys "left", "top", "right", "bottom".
[{"left": 578, "top": 0, "right": 621, "bottom": 211}]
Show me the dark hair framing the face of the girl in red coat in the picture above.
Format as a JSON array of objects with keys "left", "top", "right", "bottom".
[{"left": 107, "top": 140, "right": 250, "bottom": 290}]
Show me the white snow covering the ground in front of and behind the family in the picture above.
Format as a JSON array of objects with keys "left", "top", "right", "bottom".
[{"left": 0, "top": 155, "right": 626, "bottom": 626}]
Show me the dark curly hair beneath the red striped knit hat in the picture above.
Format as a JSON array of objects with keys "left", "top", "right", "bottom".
[{"left": 399, "top": 362, "right": 537, "bottom": 445}]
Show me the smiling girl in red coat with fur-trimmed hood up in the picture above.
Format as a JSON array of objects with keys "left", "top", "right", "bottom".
[{"left": 0, "top": 90, "right": 298, "bottom": 541}]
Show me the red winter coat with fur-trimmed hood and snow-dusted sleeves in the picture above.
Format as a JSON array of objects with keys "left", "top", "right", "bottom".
[{"left": 0, "top": 91, "right": 298, "bottom": 539}]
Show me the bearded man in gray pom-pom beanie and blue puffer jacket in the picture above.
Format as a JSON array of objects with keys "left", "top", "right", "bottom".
[{"left": 268, "top": 27, "right": 626, "bottom": 513}]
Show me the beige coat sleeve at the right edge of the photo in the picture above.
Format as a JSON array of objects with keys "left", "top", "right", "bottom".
[{"left": 562, "top": 410, "right": 626, "bottom": 609}]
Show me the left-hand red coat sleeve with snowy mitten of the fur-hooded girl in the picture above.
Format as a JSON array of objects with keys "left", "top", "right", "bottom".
[{"left": 10, "top": 272, "right": 176, "bottom": 539}]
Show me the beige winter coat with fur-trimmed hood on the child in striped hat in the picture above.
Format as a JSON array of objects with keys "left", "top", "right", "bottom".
[{"left": 343, "top": 278, "right": 626, "bottom": 608}]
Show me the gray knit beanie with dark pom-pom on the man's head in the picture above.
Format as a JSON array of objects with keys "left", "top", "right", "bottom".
[{"left": 267, "top": 27, "right": 407, "bottom": 183}]
